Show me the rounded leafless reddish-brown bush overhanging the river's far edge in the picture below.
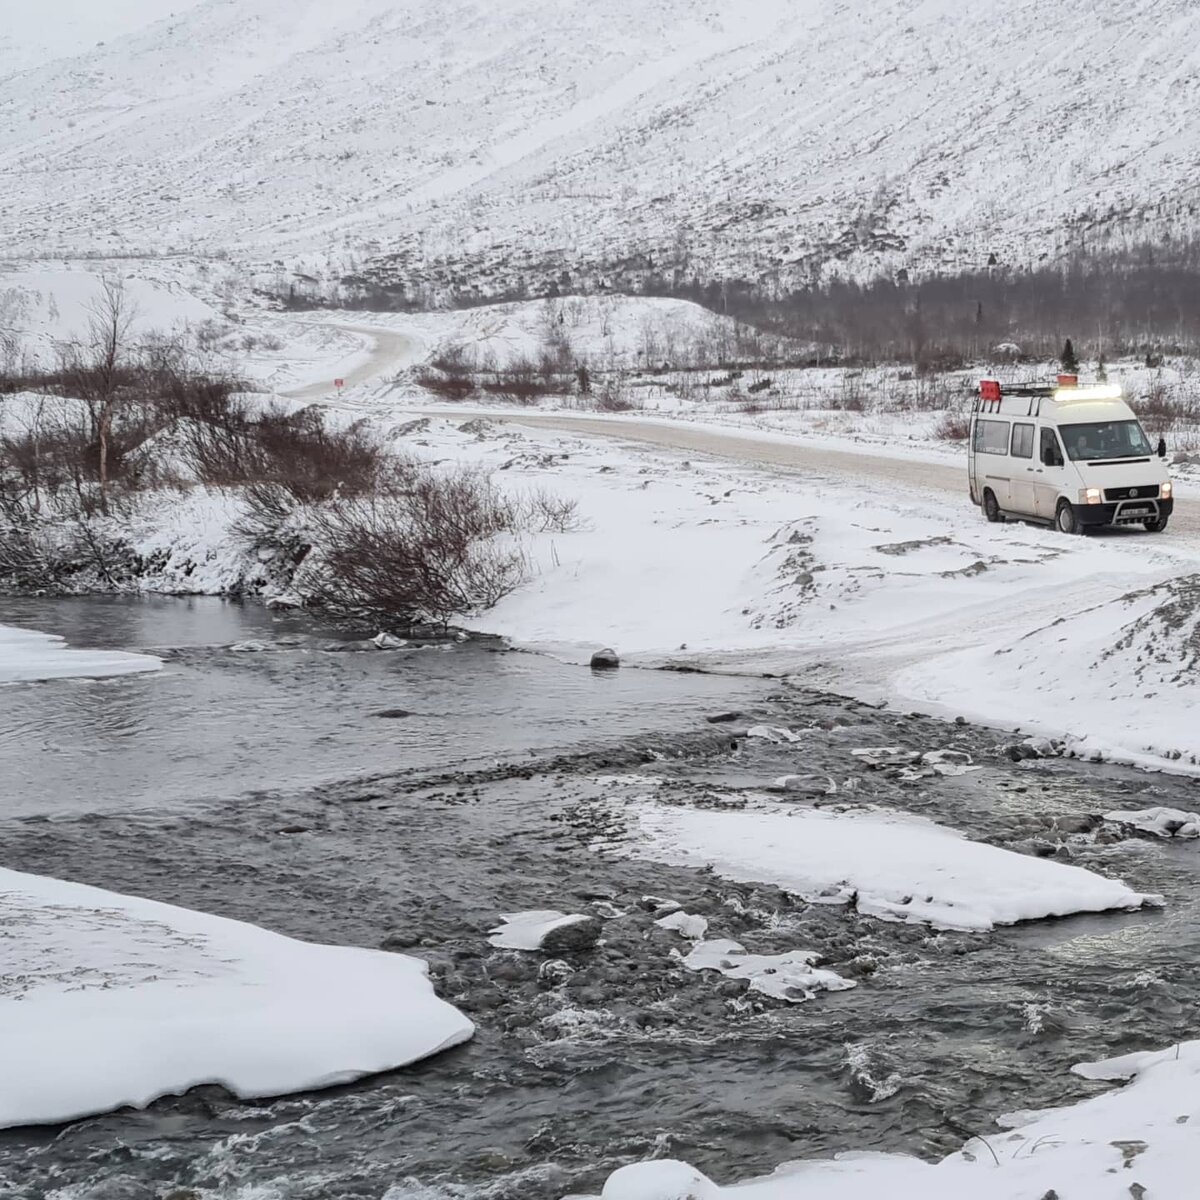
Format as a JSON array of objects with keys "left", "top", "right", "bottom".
[{"left": 304, "top": 469, "right": 527, "bottom": 625}]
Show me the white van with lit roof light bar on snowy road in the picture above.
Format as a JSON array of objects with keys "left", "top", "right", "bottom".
[{"left": 967, "top": 376, "right": 1175, "bottom": 533}]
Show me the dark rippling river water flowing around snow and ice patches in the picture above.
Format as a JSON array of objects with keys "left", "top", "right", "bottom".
[{"left": 0, "top": 600, "right": 1200, "bottom": 1200}]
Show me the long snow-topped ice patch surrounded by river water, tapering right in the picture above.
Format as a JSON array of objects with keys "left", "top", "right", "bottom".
[{"left": 622, "top": 803, "right": 1162, "bottom": 930}]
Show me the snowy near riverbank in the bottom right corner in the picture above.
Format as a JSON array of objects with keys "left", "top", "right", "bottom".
[{"left": 585, "top": 1042, "right": 1200, "bottom": 1200}]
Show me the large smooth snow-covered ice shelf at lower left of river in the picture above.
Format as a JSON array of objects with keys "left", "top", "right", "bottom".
[{"left": 0, "top": 869, "right": 474, "bottom": 1128}]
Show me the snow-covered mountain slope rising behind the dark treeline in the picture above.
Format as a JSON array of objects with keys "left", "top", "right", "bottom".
[{"left": 0, "top": 0, "right": 1200, "bottom": 287}]
